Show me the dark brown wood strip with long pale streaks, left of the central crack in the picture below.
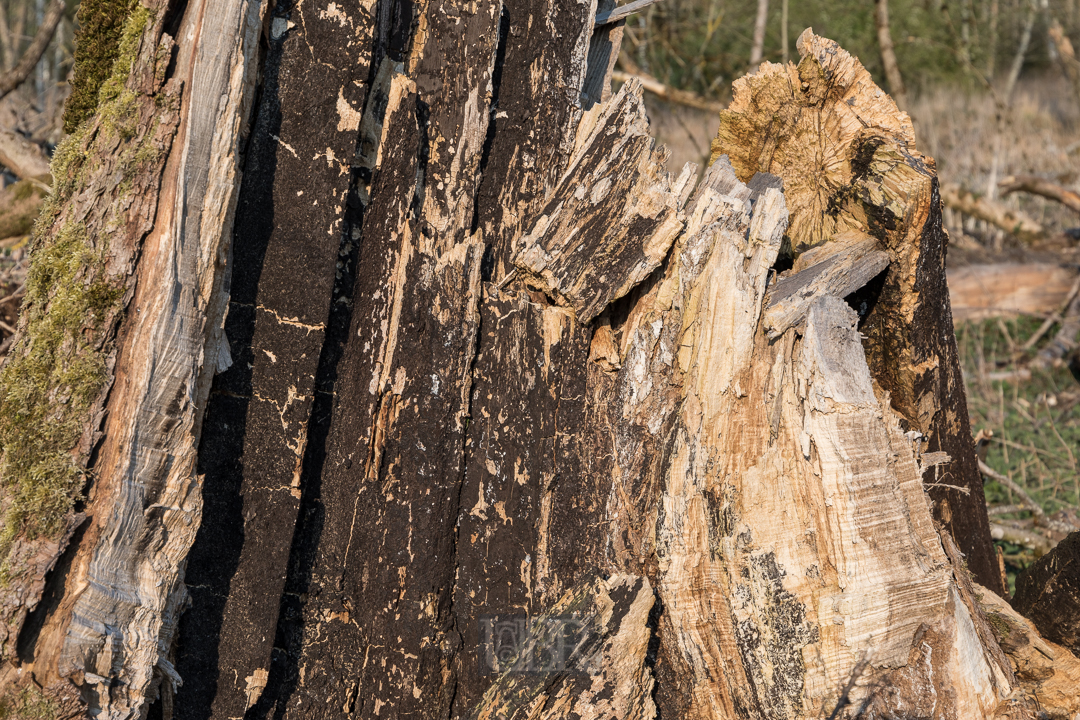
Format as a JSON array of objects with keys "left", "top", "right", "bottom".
[{"left": 250, "top": 3, "right": 500, "bottom": 717}]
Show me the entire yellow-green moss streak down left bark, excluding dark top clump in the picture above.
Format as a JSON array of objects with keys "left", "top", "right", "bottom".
[{"left": 0, "top": 4, "right": 159, "bottom": 584}]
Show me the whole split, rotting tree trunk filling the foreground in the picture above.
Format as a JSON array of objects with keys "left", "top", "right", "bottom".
[{"left": 0, "top": 5, "right": 1080, "bottom": 720}]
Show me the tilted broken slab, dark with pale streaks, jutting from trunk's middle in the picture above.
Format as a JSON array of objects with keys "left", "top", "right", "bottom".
[{"left": 514, "top": 81, "right": 693, "bottom": 323}]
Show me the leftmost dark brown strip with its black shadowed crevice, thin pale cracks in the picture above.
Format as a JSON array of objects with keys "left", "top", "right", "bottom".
[{"left": 176, "top": 3, "right": 373, "bottom": 718}]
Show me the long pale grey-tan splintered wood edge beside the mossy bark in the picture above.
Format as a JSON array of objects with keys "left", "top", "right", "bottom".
[{"left": 56, "top": 2, "right": 262, "bottom": 718}]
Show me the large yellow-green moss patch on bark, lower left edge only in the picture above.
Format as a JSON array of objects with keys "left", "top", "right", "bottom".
[{"left": 0, "top": 223, "right": 124, "bottom": 580}]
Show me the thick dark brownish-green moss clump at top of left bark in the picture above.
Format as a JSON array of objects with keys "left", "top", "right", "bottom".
[{"left": 64, "top": 0, "right": 134, "bottom": 133}]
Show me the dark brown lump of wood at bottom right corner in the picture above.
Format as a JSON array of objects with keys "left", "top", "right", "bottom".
[{"left": 1013, "top": 532, "right": 1080, "bottom": 657}]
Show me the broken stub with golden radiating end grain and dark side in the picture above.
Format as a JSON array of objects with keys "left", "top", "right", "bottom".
[{"left": 713, "top": 30, "right": 1003, "bottom": 592}]
